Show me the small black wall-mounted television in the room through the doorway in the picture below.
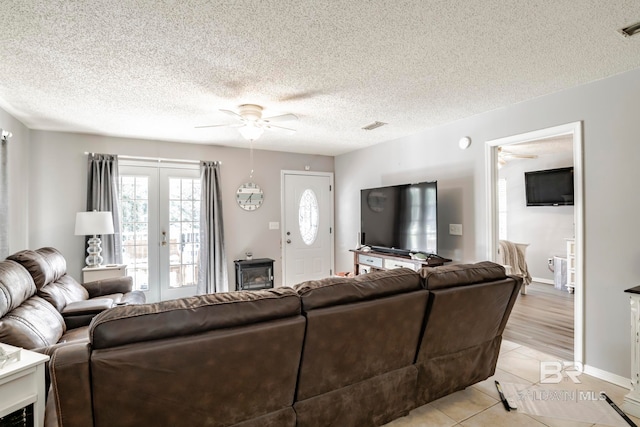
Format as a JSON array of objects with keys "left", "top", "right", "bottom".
[{"left": 524, "top": 167, "right": 573, "bottom": 206}]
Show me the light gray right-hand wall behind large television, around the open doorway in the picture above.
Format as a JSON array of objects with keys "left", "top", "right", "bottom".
[{"left": 335, "top": 70, "right": 640, "bottom": 378}]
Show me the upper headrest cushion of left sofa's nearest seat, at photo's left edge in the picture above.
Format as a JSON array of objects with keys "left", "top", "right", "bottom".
[{"left": 0, "top": 261, "right": 36, "bottom": 316}]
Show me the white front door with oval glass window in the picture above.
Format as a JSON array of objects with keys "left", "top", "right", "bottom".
[{"left": 282, "top": 171, "right": 334, "bottom": 286}]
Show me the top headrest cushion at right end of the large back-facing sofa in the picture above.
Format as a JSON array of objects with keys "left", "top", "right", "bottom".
[{"left": 420, "top": 261, "right": 507, "bottom": 290}]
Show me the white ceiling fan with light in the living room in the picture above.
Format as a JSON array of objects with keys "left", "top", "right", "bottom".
[{"left": 196, "top": 104, "right": 298, "bottom": 141}]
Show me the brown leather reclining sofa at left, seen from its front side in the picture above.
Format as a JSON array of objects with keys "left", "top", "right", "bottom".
[{"left": 0, "top": 248, "right": 145, "bottom": 352}]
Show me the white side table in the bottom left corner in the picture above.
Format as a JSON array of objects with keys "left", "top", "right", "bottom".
[{"left": 0, "top": 344, "right": 49, "bottom": 427}]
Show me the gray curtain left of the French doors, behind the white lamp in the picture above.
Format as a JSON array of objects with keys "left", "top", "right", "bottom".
[{"left": 85, "top": 153, "right": 122, "bottom": 264}]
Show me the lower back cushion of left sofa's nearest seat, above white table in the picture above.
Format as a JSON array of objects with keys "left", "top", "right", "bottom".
[{"left": 0, "top": 295, "right": 66, "bottom": 350}]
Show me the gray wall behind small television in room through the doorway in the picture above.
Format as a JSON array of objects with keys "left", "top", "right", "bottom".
[{"left": 499, "top": 152, "right": 575, "bottom": 282}]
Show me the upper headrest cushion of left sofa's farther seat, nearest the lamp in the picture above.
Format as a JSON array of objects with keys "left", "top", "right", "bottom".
[{"left": 7, "top": 248, "right": 67, "bottom": 289}]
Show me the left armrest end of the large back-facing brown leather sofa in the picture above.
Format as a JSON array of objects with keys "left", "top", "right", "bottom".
[{"left": 46, "top": 343, "right": 93, "bottom": 427}]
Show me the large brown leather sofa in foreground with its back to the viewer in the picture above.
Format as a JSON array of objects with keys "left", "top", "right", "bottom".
[{"left": 47, "top": 262, "right": 521, "bottom": 427}]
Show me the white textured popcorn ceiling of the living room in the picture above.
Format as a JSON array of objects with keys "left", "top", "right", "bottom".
[{"left": 0, "top": 0, "right": 640, "bottom": 155}]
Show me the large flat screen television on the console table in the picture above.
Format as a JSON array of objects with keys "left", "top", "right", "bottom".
[{"left": 360, "top": 181, "right": 438, "bottom": 254}]
